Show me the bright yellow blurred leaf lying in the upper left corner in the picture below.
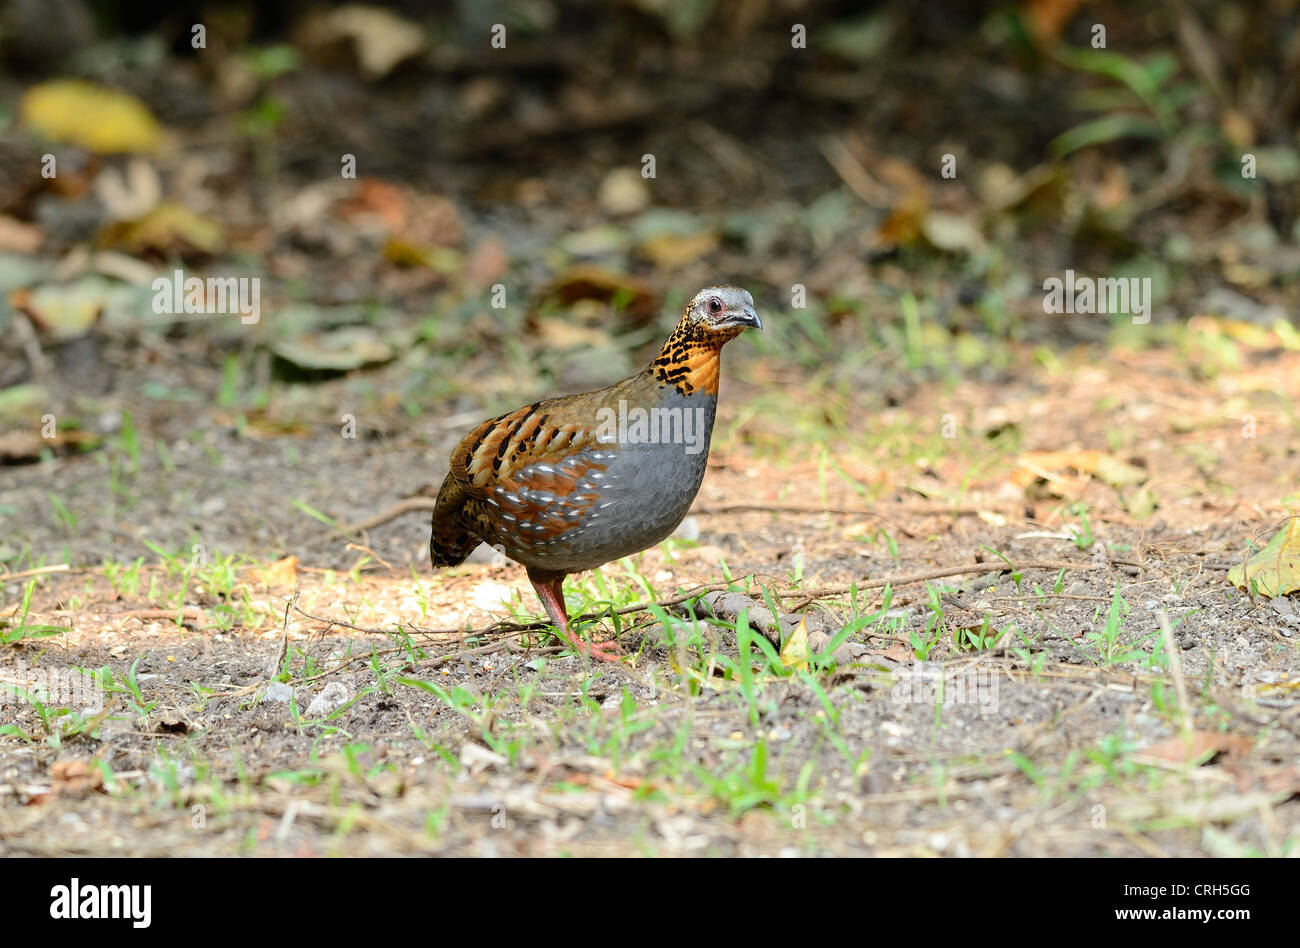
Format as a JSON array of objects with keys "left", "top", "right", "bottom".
[{"left": 20, "top": 79, "right": 163, "bottom": 155}]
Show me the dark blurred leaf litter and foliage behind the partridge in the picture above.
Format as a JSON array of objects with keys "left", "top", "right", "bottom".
[{"left": 0, "top": 0, "right": 1300, "bottom": 449}]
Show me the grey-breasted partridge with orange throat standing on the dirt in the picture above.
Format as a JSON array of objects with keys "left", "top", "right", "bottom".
[{"left": 429, "top": 286, "right": 763, "bottom": 662}]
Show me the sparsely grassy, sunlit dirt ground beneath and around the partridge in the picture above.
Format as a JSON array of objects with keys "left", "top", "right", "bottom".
[{"left": 0, "top": 343, "right": 1300, "bottom": 856}]
